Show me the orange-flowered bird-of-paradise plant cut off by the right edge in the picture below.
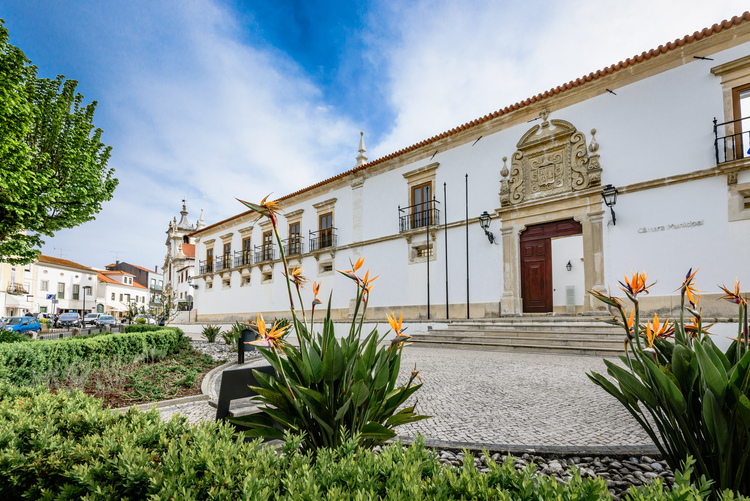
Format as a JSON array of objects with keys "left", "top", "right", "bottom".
[{"left": 588, "top": 270, "right": 750, "bottom": 495}]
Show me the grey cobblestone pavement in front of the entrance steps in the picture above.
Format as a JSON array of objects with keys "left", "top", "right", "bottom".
[{"left": 162, "top": 346, "right": 653, "bottom": 448}]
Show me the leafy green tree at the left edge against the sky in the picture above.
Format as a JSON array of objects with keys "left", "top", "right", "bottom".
[{"left": 0, "top": 19, "right": 118, "bottom": 264}]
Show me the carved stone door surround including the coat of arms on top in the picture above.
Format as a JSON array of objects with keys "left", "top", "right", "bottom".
[{"left": 495, "top": 110, "right": 604, "bottom": 315}]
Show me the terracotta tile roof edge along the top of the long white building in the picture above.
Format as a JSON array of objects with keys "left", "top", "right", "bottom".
[{"left": 190, "top": 11, "right": 750, "bottom": 235}]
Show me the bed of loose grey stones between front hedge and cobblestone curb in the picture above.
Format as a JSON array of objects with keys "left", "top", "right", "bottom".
[{"left": 373, "top": 446, "right": 674, "bottom": 500}]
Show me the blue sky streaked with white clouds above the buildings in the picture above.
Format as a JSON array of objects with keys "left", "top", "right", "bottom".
[{"left": 0, "top": 0, "right": 747, "bottom": 268}]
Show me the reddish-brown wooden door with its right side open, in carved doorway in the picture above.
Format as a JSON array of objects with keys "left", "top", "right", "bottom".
[{"left": 521, "top": 219, "right": 583, "bottom": 313}]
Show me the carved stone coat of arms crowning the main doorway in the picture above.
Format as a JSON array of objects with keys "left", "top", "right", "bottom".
[{"left": 500, "top": 110, "right": 602, "bottom": 207}]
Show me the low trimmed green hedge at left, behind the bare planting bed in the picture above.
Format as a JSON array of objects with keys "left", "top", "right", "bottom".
[{"left": 0, "top": 327, "right": 187, "bottom": 386}]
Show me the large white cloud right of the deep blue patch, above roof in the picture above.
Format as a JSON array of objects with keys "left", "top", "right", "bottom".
[{"left": 371, "top": 0, "right": 746, "bottom": 158}]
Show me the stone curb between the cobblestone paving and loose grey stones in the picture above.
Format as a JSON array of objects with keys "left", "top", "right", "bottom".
[{"left": 396, "top": 436, "right": 661, "bottom": 457}]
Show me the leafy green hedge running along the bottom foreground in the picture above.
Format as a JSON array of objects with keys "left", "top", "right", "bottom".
[{"left": 0, "top": 387, "right": 746, "bottom": 501}]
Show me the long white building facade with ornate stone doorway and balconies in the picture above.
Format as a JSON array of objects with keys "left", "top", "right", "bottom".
[{"left": 189, "top": 14, "right": 750, "bottom": 321}]
